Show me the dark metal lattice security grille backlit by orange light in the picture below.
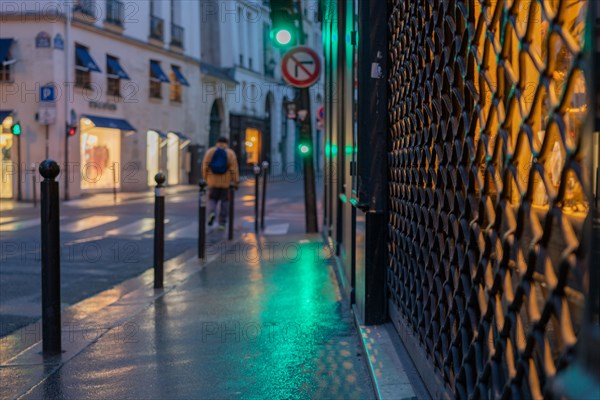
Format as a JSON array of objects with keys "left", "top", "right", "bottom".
[{"left": 387, "top": 0, "right": 589, "bottom": 398}]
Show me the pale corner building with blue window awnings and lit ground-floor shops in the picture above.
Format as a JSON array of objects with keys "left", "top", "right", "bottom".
[{"left": 0, "top": 0, "right": 220, "bottom": 199}]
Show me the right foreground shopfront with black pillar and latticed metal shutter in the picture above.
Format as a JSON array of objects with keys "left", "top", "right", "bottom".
[{"left": 321, "top": 0, "right": 600, "bottom": 399}]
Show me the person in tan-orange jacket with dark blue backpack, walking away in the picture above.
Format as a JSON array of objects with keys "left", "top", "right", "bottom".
[{"left": 202, "top": 137, "right": 240, "bottom": 230}]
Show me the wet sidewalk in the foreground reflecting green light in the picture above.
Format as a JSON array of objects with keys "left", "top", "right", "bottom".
[{"left": 0, "top": 235, "right": 374, "bottom": 399}]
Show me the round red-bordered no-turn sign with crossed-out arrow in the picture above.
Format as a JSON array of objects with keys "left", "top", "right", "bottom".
[{"left": 281, "top": 46, "right": 321, "bottom": 88}]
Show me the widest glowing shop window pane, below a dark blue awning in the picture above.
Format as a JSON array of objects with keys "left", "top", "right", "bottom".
[{"left": 81, "top": 119, "right": 121, "bottom": 190}]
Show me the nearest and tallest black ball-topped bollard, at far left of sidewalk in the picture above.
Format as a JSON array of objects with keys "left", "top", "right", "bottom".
[{"left": 39, "top": 160, "right": 62, "bottom": 355}]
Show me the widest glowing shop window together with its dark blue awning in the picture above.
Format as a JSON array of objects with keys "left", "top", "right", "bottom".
[{"left": 80, "top": 115, "right": 135, "bottom": 190}]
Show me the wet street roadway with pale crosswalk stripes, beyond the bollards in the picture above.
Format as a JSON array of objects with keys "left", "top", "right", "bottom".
[{"left": 0, "top": 179, "right": 324, "bottom": 340}]
